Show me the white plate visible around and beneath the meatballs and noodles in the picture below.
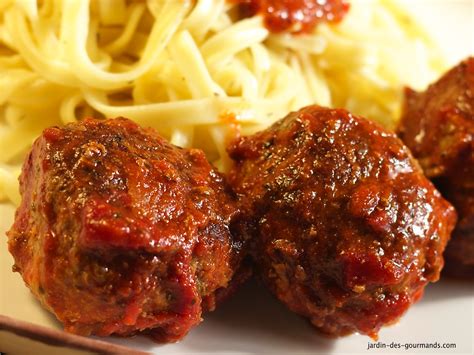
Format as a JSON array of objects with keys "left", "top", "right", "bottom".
[{"left": 0, "top": 0, "right": 474, "bottom": 354}]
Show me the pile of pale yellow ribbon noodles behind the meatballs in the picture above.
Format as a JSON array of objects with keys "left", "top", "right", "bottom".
[{"left": 0, "top": 0, "right": 444, "bottom": 203}]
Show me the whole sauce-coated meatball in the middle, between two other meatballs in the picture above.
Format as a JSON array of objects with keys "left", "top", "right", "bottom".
[{"left": 229, "top": 106, "right": 456, "bottom": 338}]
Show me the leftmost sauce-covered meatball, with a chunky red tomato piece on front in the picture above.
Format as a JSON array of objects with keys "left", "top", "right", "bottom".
[{"left": 7, "top": 118, "right": 241, "bottom": 342}]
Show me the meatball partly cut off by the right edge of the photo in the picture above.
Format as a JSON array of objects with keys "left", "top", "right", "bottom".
[{"left": 399, "top": 58, "right": 474, "bottom": 277}]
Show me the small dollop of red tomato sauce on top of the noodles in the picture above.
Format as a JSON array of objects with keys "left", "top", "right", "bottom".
[{"left": 231, "top": 0, "right": 349, "bottom": 33}]
